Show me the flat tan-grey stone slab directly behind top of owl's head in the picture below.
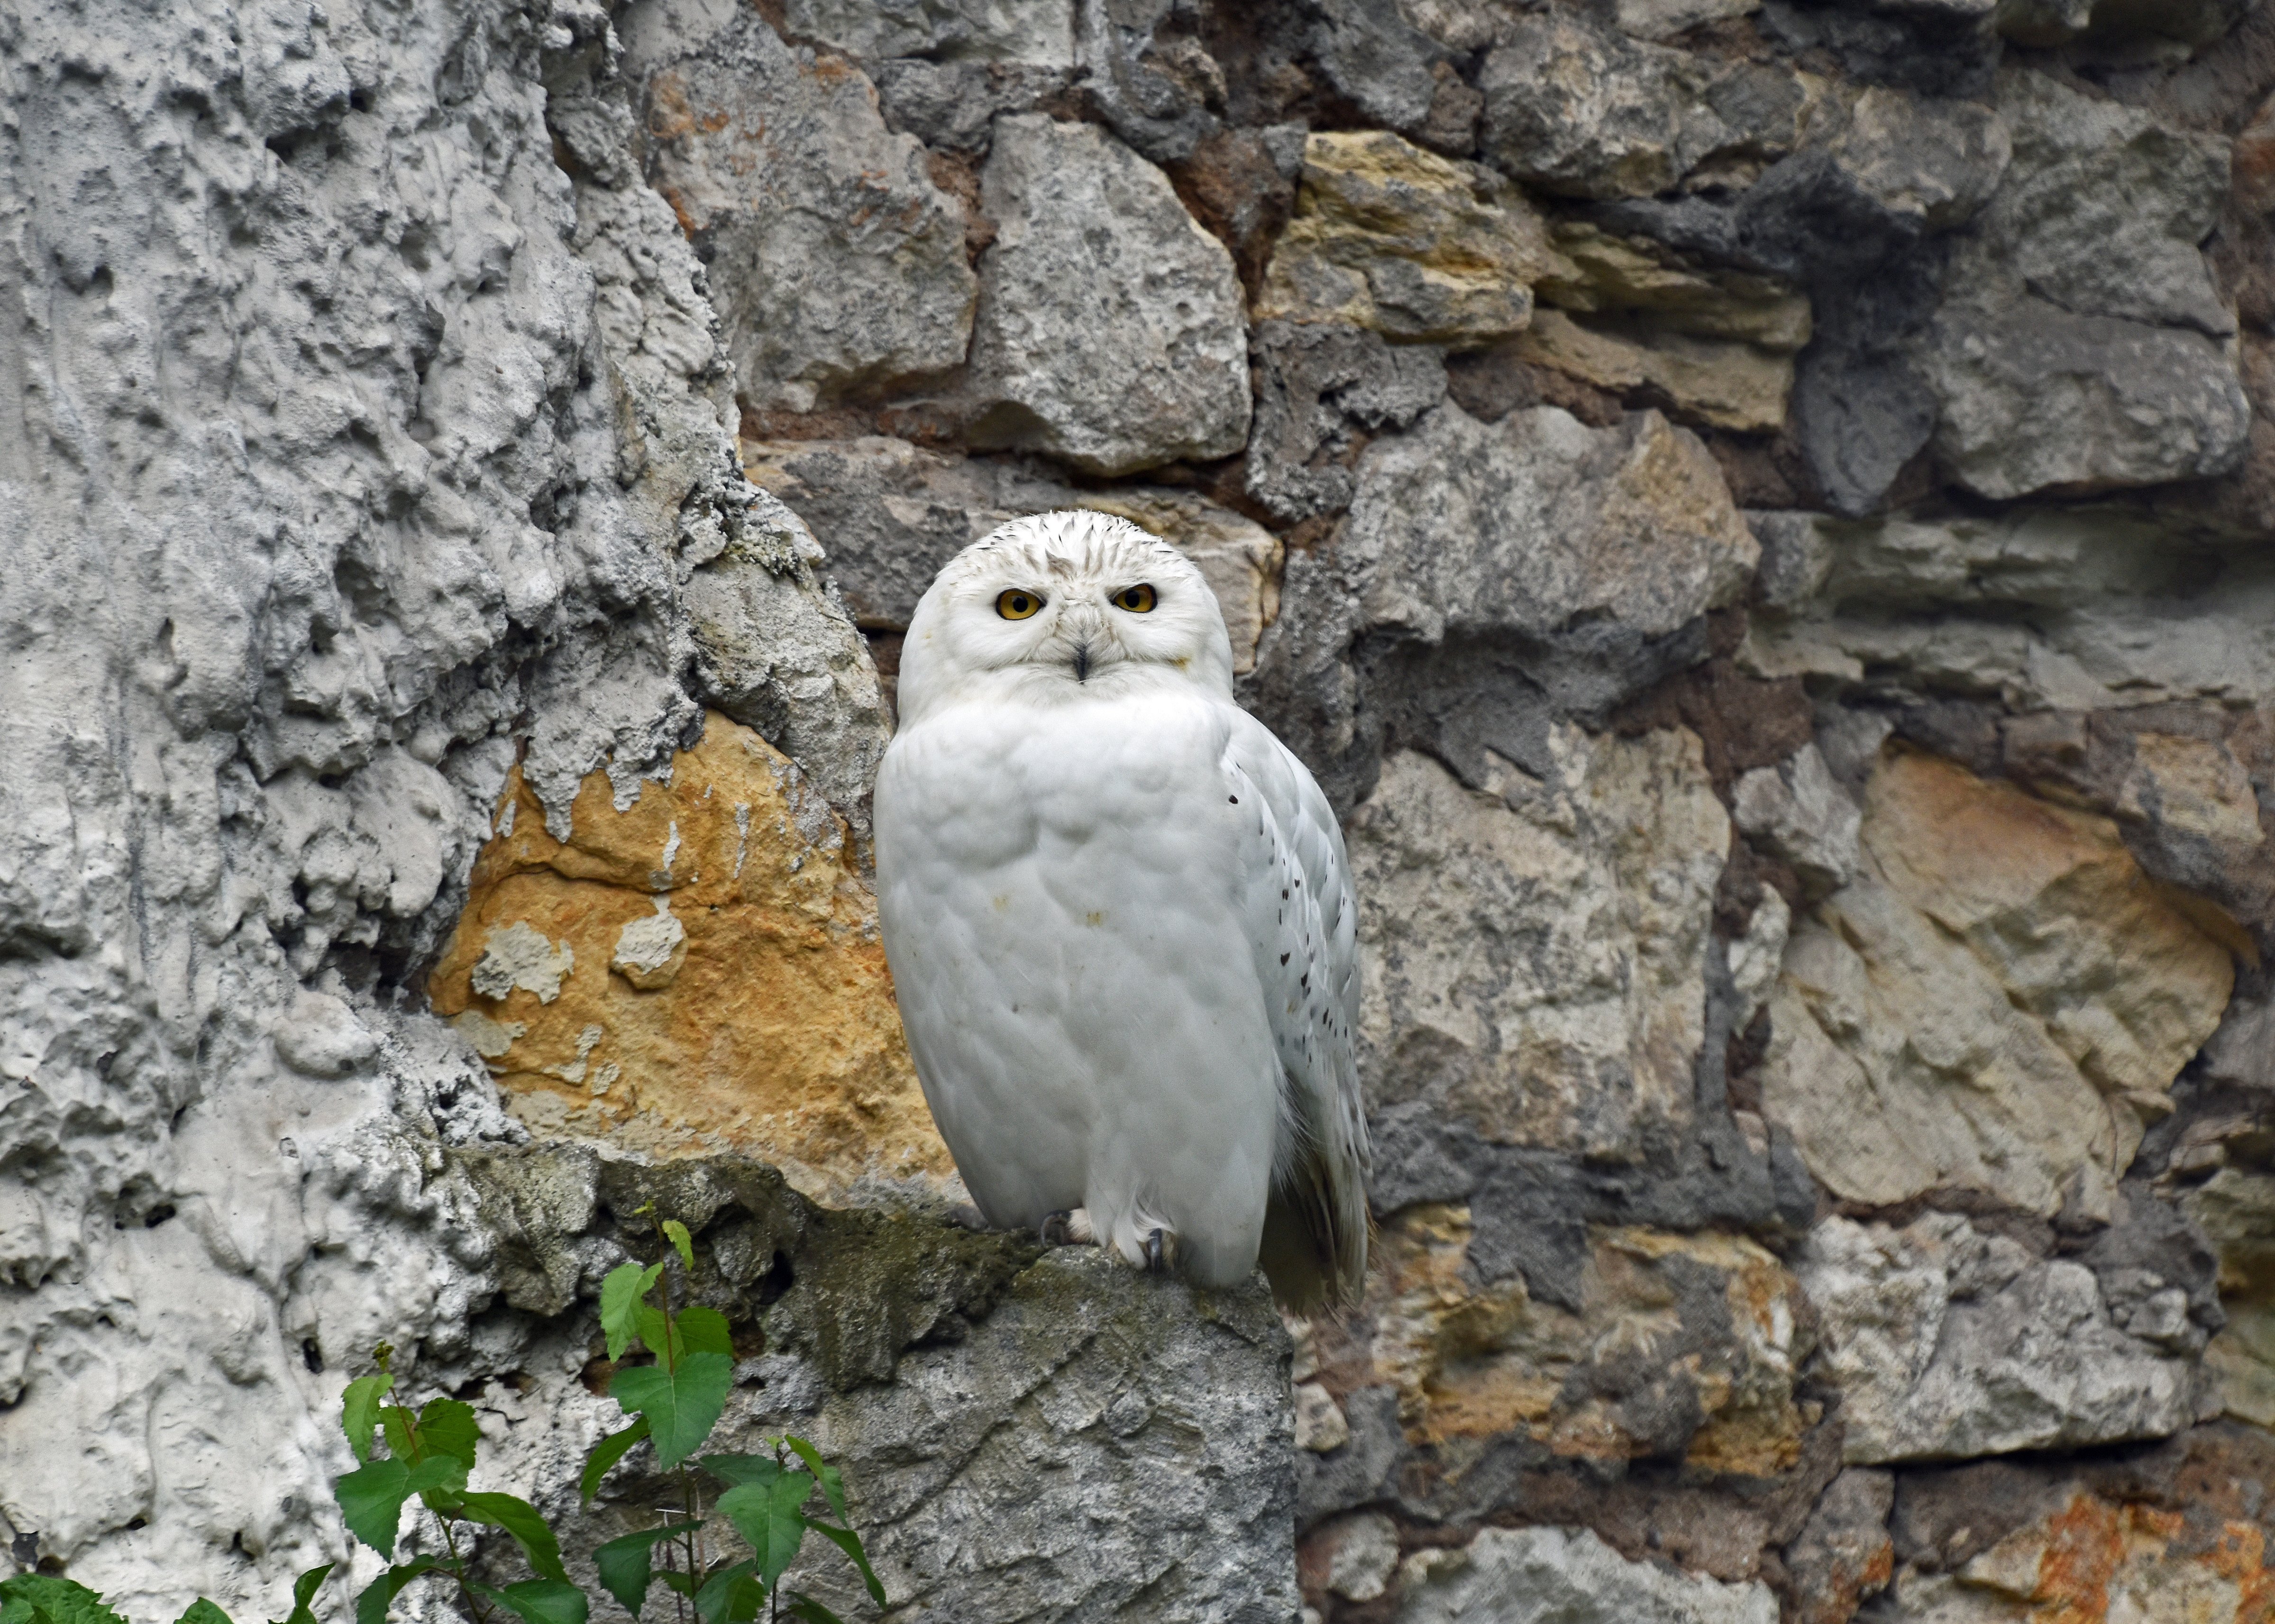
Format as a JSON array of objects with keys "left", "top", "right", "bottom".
[{"left": 741, "top": 434, "right": 1281, "bottom": 668}]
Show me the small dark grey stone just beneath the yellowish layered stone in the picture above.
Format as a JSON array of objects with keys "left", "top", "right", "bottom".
[{"left": 1247, "top": 321, "right": 1444, "bottom": 521}]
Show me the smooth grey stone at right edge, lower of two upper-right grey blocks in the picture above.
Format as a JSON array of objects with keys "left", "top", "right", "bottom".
[{"left": 1922, "top": 298, "right": 2252, "bottom": 498}]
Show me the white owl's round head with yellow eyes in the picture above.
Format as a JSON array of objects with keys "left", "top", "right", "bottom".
[{"left": 901, "top": 512, "right": 1233, "bottom": 726}]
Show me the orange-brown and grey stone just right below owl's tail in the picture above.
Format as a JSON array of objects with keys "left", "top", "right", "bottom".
[{"left": 1315, "top": 1203, "right": 1811, "bottom": 1476}]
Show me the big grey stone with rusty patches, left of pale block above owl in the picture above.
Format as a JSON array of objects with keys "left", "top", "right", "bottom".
[{"left": 623, "top": 0, "right": 976, "bottom": 411}]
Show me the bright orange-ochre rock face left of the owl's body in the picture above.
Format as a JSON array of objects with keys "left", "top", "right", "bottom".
[{"left": 428, "top": 714, "right": 953, "bottom": 1199}]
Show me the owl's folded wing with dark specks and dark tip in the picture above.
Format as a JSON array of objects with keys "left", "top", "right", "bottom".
[{"left": 1222, "top": 714, "right": 1372, "bottom": 1313}]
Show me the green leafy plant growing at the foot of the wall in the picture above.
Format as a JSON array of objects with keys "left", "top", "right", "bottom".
[{"left": 0, "top": 1208, "right": 885, "bottom": 1624}]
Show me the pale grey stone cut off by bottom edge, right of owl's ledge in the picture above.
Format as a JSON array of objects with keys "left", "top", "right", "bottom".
[{"left": 1395, "top": 1528, "right": 1777, "bottom": 1624}]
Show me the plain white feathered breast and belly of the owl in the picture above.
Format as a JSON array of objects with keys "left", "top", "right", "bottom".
[{"left": 876, "top": 698, "right": 1279, "bottom": 1283}]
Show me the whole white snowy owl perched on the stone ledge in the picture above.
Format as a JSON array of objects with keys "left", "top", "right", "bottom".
[{"left": 876, "top": 512, "right": 1367, "bottom": 1308}]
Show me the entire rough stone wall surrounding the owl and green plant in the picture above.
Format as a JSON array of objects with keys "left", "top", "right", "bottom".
[{"left": 13, "top": 0, "right": 2275, "bottom": 1624}]
